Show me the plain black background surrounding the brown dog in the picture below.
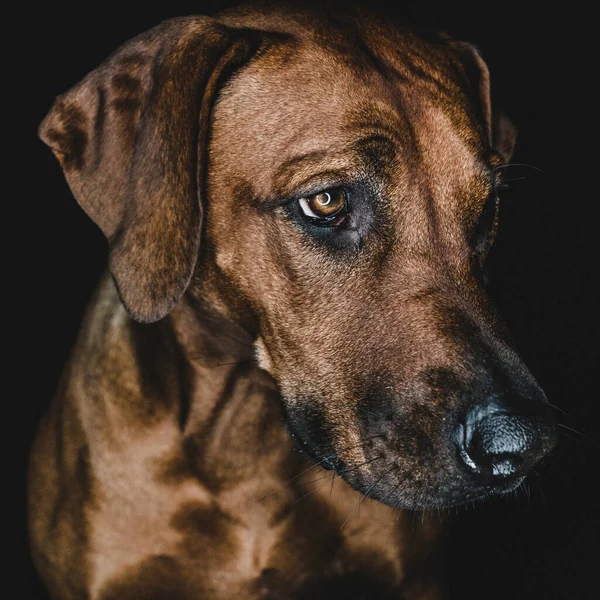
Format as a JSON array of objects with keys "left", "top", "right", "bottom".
[{"left": 22, "top": 1, "right": 600, "bottom": 600}]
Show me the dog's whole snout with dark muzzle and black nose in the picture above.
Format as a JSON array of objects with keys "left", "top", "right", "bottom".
[{"left": 281, "top": 284, "right": 557, "bottom": 510}]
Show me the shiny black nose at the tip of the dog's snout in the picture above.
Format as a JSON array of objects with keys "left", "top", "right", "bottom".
[{"left": 459, "top": 405, "right": 557, "bottom": 485}]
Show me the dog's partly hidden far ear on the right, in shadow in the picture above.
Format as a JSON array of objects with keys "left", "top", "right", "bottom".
[{"left": 450, "top": 40, "right": 517, "bottom": 164}]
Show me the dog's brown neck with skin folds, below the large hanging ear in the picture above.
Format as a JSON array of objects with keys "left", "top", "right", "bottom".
[{"left": 79, "top": 276, "right": 281, "bottom": 446}]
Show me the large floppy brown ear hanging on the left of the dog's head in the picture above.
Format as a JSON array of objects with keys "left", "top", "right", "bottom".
[{"left": 40, "top": 17, "right": 260, "bottom": 322}]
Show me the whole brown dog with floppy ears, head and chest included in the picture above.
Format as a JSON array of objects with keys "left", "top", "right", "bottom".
[{"left": 30, "top": 5, "right": 555, "bottom": 600}]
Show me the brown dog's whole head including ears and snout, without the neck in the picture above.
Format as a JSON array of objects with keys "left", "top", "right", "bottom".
[{"left": 41, "top": 3, "right": 556, "bottom": 508}]
